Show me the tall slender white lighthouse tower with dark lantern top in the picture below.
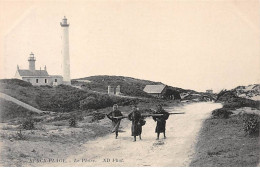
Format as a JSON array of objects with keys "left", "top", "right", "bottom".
[{"left": 60, "top": 16, "right": 71, "bottom": 85}]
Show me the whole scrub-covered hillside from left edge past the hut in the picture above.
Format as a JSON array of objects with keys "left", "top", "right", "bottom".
[{"left": 0, "top": 76, "right": 215, "bottom": 112}]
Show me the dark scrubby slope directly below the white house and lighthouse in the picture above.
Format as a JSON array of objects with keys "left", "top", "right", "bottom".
[{"left": 0, "top": 79, "right": 140, "bottom": 112}]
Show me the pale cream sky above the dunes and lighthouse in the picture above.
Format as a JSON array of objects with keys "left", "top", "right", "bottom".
[{"left": 0, "top": 0, "right": 260, "bottom": 92}]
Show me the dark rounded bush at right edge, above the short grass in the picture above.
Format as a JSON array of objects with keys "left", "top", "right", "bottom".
[{"left": 243, "top": 114, "right": 260, "bottom": 136}]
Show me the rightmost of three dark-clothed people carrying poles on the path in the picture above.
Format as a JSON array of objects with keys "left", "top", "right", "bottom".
[{"left": 153, "top": 105, "right": 169, "bottom": 140}]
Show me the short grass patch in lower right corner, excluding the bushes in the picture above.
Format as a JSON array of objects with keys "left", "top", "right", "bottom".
[{"left": 190, "top": 115, "right": 260, "bottom": 167}]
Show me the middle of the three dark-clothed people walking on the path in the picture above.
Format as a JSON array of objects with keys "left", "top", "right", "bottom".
[{"left": 128, "top": 106, "right": 142, "bottom": 142}]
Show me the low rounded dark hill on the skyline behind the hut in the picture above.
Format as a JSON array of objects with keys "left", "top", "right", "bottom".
[{"left": 72, "top": 75, "right": 197, "bottom": 97}]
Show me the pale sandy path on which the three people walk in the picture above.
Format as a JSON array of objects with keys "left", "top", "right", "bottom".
[{"left": 48, "top": 103, "right": 221, "bottom": 166}]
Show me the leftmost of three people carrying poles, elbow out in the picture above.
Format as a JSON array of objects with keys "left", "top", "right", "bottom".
[{"left": 107, "top": 104, "right": 123, "bottom": 139}]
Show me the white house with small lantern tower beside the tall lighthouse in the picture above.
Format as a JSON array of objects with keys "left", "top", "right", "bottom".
[{"left": 15, "top": 53, "right": 63, "bottom": 86}]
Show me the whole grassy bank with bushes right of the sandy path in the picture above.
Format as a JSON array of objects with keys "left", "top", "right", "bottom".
[{"left": 190, "top": 87, "right": 260, "bottom": 167}]
